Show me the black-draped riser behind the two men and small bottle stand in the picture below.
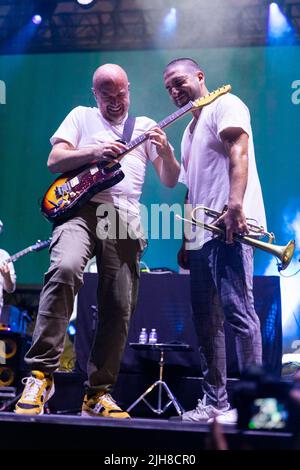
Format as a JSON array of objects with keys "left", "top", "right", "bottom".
[{"left": 75, "top": 273, "right": 282, "bottom": 377}]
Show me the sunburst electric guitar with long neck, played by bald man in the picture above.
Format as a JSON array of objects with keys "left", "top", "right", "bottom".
[{"left": 41, "top": 85, "right": 231, "bottom": 222}]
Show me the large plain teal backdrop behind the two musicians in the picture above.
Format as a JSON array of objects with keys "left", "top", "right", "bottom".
[{"left": 0, "top": 46, "right": 300, "bottom": 346}]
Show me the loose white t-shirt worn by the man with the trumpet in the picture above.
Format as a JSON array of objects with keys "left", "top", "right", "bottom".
[{"left": 179, "top": 93, "right": 266, "bottom": 248}]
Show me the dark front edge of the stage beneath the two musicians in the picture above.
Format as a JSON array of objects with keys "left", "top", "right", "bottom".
[{"left": 0, "top": 412, "right": 295, "bottom": 452}]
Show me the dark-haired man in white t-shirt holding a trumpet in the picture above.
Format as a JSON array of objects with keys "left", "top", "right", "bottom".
[{"left": 164, "top": 58, "right": 266, "bottom": 424}]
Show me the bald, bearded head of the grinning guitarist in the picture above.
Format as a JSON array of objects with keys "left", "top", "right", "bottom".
[{"left": 93, "top": 64, "right": 129, "bottom": 124}]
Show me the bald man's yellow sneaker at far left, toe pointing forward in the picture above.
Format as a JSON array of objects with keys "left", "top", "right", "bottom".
[{"left": 15, "top": 370, "right": 54, "bottom": 415}]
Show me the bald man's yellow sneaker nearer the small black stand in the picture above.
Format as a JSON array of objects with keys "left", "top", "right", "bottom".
[{"left": 81, "top": 391, "right": 130, "bottom": 419}]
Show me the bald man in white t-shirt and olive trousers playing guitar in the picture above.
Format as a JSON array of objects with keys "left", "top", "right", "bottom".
[{"left": 15, "top": 64, "right": 180, "bottom": 419}]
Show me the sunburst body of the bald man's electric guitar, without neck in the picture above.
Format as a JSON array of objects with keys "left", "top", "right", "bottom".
[{"left": 41, "top": 163, "right": 125, "bottom": 222}]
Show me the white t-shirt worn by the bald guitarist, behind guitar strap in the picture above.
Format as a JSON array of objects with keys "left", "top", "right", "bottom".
[{"left": 50, "top": 106, "right": 157, "bottom": 219}]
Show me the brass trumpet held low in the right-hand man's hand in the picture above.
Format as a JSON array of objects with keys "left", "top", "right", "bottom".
[{"left": 176, "top": 205, "right": 295, "bottom": 271}]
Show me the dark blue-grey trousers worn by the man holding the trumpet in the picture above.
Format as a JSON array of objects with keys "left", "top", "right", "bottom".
[{"left": 189, "top": 239, "right": 262, "bottom": 409}]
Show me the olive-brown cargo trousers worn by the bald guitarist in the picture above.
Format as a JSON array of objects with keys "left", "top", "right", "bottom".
[{"left": 25, "top": 203, "right": 141, "bottom": 391}]
